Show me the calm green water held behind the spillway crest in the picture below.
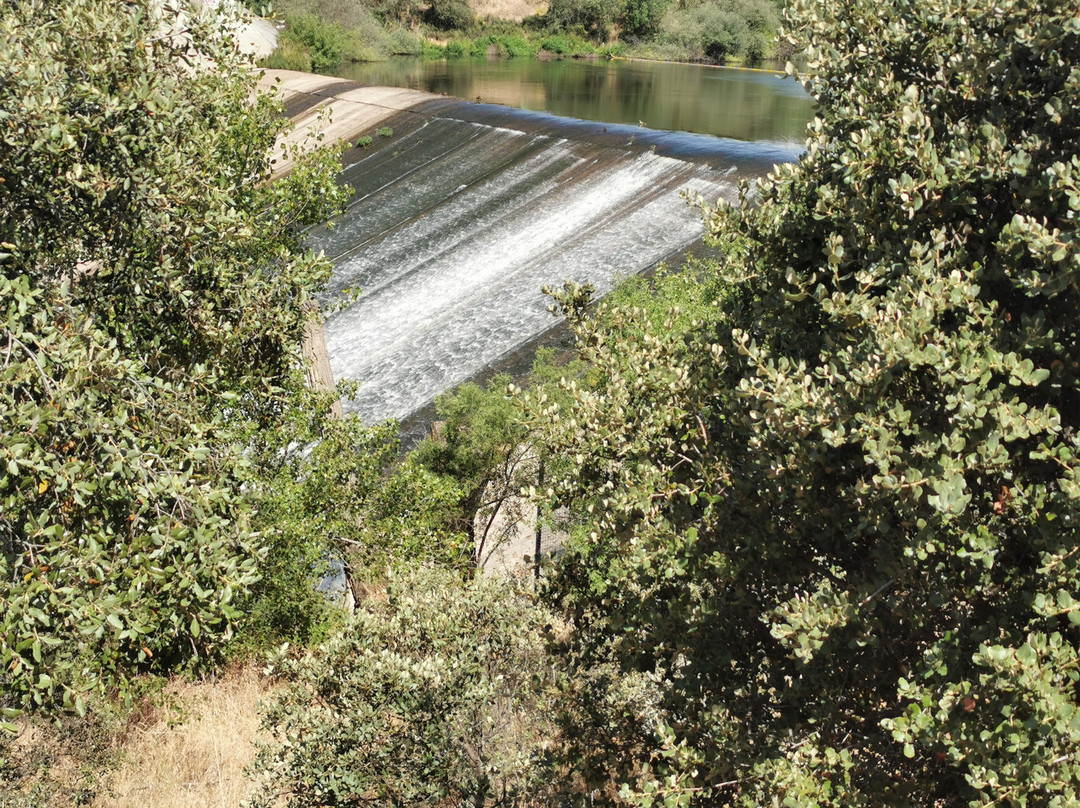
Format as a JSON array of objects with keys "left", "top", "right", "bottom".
[{"left": 339, "top": 58, "right": 813, "bottom": 143}]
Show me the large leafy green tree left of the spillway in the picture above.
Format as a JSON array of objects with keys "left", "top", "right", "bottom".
[{"left": 0, "top": 0, "right": 342, "bottom": 714}]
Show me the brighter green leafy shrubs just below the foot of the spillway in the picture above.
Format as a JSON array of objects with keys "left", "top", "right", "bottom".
[{"left": 240, "top": 391, "right": 472, "bottom": 651}]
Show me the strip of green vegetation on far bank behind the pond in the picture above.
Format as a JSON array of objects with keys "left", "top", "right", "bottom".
[{"left": 265, "top": 0, "right": 789, "bottom": 72}]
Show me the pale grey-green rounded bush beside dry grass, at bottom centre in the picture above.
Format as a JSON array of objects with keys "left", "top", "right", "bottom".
[{"left": 253, "top": 570, "right": 553, "bottom": 808}]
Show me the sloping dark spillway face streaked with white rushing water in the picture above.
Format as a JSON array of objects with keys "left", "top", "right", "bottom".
[{"left": 311, "top": 105, "right": 756, "bottom": 422}]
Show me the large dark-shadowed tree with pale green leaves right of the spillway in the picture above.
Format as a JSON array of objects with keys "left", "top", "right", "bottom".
[{"left": 535, "top": 0, "right": 1080, "bottom": 806}]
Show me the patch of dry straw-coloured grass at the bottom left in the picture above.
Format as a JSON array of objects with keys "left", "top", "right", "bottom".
[{"left": 91, "top": 669, "right": 267, "bottom": 808}]
